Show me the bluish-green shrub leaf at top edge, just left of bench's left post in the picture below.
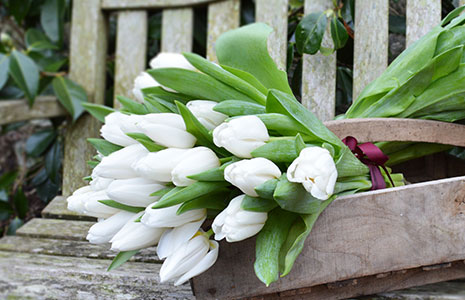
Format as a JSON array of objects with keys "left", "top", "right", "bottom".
[{"left": 40, "top": 0, "right": 66, "bottom": 44}]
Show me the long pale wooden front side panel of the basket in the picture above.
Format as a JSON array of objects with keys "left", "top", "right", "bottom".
[{"left": 194, "top": 177, "right": 465, "bottom": 299}]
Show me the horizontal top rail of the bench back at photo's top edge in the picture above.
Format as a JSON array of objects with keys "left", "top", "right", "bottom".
[{"left": 102, "top": 0, "right": 219, "bottom": 9}]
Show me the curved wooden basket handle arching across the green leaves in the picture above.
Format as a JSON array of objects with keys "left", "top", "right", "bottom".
[{"left": 325, "top": 118, "right": 465, "bottom": 147}]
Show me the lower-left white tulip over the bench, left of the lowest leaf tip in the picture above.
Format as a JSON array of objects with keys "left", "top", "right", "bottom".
[{"left": 86, "top": 211, "right": 135, "bottom": 244}]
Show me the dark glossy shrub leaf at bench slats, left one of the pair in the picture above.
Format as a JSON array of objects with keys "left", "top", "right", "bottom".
[{"left": 295, "top": 12, "right": 327, "bottom": 54}]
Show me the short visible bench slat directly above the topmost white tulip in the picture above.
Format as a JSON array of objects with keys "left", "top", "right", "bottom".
[{"left": 161, "top": 8, "right": 194, "bottom": 52}]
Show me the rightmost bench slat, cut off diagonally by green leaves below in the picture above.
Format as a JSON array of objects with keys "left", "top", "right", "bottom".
[{"left": 406, "top": 0, "right": 441, "bottom": 47}]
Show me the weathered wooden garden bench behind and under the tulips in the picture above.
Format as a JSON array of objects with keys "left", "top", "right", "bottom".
[{"left": 0, "top": 0, "right": 465, "bottom": 299}]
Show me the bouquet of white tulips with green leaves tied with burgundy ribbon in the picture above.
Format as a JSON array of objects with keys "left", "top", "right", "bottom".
[{"left": 68, "top": 24, "right": 403, "bottom": 285}]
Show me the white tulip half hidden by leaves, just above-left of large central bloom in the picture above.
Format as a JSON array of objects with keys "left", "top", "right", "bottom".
[{"left": 186, "top": 100, "right": 228, "bottom": 130}]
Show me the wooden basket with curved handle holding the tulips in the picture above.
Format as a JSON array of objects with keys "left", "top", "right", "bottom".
[{"left": 192, "top": 119, "right": 465, "bottom": 299}]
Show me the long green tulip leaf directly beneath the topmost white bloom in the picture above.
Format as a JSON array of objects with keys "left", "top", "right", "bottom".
[{"left": 147, "top": 68, "right": 254, "bottom": 102}]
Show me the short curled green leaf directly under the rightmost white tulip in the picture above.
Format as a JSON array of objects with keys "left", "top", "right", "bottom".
[{"left": 273, "top": 173, "right": 322, "bottom": 214}]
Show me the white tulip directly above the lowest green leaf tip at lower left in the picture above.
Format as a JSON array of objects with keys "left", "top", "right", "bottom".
[{"left": 110, "top": 212, "right": 165, "bottom": 251}]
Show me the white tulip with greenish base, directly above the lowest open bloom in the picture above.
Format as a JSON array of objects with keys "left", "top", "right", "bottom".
[{"left": 141, "top": 202, "right": 207, "bottom": 227}]
